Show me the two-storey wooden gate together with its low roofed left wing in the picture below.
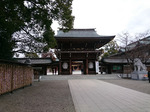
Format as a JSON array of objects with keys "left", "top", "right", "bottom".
[{"left": 16, "top": 29, "right": 115, "bottom": 78}]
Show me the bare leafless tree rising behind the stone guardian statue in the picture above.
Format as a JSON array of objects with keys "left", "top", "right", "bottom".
[{"left": 119, "top": 30, "right": 150, "bottom": 70}]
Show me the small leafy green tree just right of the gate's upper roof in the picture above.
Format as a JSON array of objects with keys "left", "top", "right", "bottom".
[{"left": 103, "top": 40, "right": 119, "bottom": 57}]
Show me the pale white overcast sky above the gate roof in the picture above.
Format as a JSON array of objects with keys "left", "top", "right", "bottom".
[{"left": 54, "top": 0, "right": 150, "bottom": 35}]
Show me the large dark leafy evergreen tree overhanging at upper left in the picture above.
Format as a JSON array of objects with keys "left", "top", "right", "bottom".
[{"left": 0, "top": 0, "right": 74, "bottom": 59}]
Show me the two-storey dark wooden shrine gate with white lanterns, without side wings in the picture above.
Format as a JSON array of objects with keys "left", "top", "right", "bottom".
[{"left": 55, "top": 29, "right": 115, "bottom": 75}]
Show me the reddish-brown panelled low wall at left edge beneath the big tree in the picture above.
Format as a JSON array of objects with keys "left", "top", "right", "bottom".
[{"left": 0, "top": 60, "right": 33, "bottom": 95}]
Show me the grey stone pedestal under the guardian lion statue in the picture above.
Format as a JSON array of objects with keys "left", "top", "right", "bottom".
[{"left": 131, "top": 71, "right": 148, "bottom": 80}]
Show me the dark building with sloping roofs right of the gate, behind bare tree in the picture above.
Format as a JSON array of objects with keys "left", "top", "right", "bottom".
[{"left": 101, "top": 36, "right": 150, "bottom": 74}]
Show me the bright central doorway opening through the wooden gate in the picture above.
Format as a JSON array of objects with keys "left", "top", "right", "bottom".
[{"left": 72, "top": 61, "right": 83, "bottom": 74}]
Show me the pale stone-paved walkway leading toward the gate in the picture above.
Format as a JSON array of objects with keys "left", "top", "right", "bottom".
[{"left": 68, "top": 80, "right": 150, "bottom": 112}]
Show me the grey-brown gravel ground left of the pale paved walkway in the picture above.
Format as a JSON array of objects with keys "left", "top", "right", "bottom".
[{"left": 0, "top": 81, "right": 75, "bottom": 112}]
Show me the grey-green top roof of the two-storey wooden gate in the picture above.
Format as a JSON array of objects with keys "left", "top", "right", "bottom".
[{"left": 55, "top": 29, "right": 115, "bottom": 38}]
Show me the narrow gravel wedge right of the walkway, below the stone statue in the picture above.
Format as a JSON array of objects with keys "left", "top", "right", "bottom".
[{"left": 103, "top": 79, "right": 150, "bottom": 94}]
